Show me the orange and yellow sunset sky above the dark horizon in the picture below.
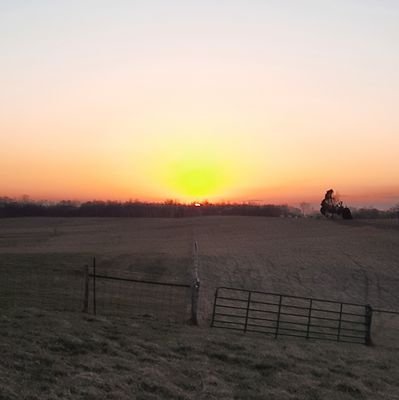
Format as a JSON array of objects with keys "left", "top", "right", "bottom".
[{"left": 0, "top": 0, "right": 399, "bottom": 207}]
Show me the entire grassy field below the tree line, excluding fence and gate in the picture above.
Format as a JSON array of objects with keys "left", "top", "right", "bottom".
[{"left": 0, "top": 217, "right": 399, "bottom": 399}]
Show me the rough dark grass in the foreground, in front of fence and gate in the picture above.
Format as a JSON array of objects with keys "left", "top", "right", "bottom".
[{"left": 0, "top": 308, "right": 399, "bottom": 400}]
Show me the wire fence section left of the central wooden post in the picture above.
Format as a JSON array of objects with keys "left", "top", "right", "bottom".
[{"left": 0, "top": 254, "right": 193, "bottom": 322}]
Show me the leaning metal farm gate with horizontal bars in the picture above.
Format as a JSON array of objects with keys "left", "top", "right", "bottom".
[{"left": 211, "top": 287, "right": 372, "bottom": 345}]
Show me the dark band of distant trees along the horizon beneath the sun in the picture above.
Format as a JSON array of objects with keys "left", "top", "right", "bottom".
[{"left": 0, "top": 197, "right": 301, "bottom": 218}]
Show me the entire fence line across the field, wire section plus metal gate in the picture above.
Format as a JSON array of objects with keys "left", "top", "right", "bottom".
[{"left": 0, "top": 253, "right": 399, "bottom": 347}]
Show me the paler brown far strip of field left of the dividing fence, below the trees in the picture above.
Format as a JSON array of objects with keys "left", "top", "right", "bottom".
[{"left": 0, "top": 218, "right": 192, "bottom": 256}]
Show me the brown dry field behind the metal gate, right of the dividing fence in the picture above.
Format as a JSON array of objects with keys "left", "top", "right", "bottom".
[{"left": 195, "top": 217, "right": 399, "bottom": 344}]
